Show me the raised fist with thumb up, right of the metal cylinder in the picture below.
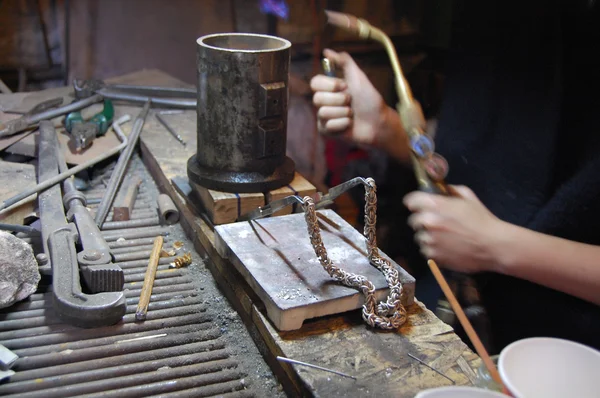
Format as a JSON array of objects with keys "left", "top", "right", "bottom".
[{"left": 310, "top": 50, "right": 408, "bottom": 160}]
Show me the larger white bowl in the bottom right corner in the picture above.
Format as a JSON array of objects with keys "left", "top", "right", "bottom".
[{"left": 498, "top": 337, "right": 600, "bottom": 398}]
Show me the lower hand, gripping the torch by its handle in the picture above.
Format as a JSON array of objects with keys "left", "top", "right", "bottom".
[{"left": 404, "top": 186, "right": 503, "bottom": 273}]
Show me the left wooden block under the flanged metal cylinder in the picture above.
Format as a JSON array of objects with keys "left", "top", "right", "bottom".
[{"left": 190, "top": 182, "right": 265, "bottom": 225}]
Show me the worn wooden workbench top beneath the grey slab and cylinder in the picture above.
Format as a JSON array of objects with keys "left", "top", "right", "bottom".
[{"left": 0, "top": 71, "right": 480, "bottom": 397}]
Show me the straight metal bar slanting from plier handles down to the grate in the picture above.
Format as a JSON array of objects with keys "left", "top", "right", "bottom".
[{"left": 95, "top": 101, "right": 150, "bottom": 229}]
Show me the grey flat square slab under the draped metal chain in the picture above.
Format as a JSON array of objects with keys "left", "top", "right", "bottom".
[{"left": 215, "top": 210, "right": 415, "bottom": 330}]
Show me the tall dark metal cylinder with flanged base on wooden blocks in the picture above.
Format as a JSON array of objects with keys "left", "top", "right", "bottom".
[{"left": 187, "top": 33, "right": 295, "bottom": 193}]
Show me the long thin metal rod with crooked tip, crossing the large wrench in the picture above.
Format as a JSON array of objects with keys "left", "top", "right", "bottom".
[{"left": 0, "top": 115, "right": 131, "bottom": 211}]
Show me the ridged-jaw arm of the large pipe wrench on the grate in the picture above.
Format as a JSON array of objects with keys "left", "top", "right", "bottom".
[{"left": 56, "top": 135, "right": 125, "bottom": 293}]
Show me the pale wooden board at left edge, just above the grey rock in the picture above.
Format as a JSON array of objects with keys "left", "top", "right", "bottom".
[{"left": 0, "top": 160, "right": 37, "bottom": 225}]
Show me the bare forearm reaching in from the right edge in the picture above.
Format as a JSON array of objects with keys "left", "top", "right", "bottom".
[{"left": 493, "top": 223, "right": 600, "bottom": 305}]
